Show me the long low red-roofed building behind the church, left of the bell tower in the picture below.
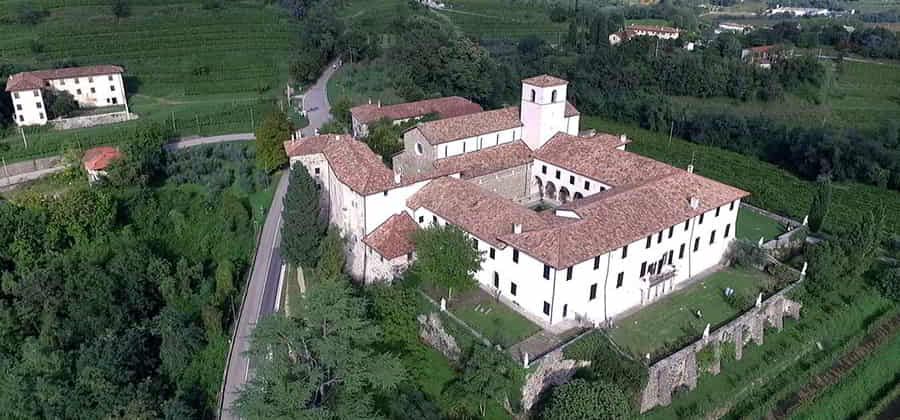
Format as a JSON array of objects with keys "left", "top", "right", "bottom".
[{"left": 350, "top": 96, "right": 483, "bottom": 137}]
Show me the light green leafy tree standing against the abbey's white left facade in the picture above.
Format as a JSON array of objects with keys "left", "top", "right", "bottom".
[{"left": 410, "top": 226, "right": 482, "bottom": 291}]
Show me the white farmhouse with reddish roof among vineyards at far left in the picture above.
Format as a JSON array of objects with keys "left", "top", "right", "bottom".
[{"left": 6, "top": 65, "right": 128, "bottom": 126}]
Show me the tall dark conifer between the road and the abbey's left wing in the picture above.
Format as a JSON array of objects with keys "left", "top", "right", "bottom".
[{"left": 281, "top": 165, "right": 326, "bottom": 267}]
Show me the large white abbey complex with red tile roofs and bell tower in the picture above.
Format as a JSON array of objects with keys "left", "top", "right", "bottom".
[{"left": 285, "top": 76, "right": 748, "bottom": 325}]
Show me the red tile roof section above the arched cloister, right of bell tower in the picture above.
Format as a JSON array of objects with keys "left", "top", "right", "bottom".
[{"left": 534, "top": 133, "right": 676, "bottom": 187}]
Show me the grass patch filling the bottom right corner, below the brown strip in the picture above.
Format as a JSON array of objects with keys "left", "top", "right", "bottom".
[{"left": 791, "top": 335, "right": 900, "bottom": 420}]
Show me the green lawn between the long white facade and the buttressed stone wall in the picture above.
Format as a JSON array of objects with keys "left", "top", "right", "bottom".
[{"left": 609, "top": 269, "right": 764, "bottom": 358}]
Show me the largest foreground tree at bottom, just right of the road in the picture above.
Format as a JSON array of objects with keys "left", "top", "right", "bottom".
[{"left": 236, "top": 279, "right": 404, "bottom": 420}]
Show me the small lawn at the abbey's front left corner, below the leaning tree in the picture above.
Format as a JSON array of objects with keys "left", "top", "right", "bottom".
[{"left": 451, "top": 298, "right": 539, "bottom": 348}]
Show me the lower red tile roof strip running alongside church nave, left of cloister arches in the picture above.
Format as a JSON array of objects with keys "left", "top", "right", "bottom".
[{"left": 434, "top": 140, "right": 532, "bottom": 179}]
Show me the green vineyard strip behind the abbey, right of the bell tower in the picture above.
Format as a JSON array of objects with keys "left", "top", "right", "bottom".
[{"left": 582, "top": 117, "right": 900, "bottom": 238}]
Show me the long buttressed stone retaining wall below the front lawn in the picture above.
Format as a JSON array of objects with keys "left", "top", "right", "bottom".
[{"left": 641, "top": 288, "right": 802, "bottom": 413}]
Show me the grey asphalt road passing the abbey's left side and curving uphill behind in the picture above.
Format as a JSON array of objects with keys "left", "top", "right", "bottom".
[{"left": 219, "top": 59, "right": 336, "bottom": 420}]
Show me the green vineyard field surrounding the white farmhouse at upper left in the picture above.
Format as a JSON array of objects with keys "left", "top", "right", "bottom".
[{"left": 0, "top": 0, "right": 297, "bottom": 160}]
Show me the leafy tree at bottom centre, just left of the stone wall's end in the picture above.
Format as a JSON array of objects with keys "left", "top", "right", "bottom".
[{"left": 444, "top": 345, "right": 524, "bottom": 417}]
